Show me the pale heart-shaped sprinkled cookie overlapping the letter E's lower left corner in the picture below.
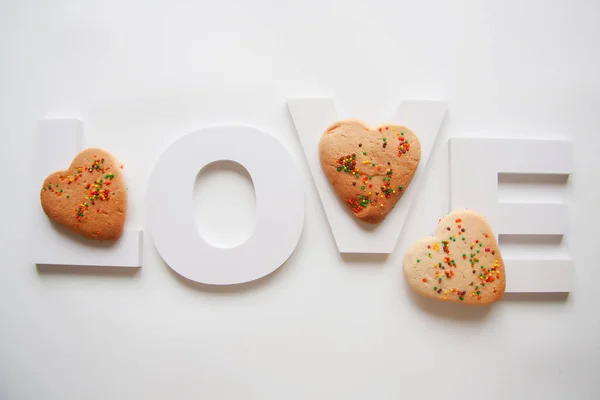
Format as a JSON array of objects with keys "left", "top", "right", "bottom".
[{"left": 404, "top": 210, "right": 506, "bottom": 304}]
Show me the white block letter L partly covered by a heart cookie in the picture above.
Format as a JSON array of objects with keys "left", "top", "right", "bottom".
[{"left": 31, "top": 119, "right": 142, "bottom": 267}]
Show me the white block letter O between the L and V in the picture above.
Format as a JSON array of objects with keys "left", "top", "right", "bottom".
[{"left": 148, "top": 125, "right": 304, "bottom": 285}]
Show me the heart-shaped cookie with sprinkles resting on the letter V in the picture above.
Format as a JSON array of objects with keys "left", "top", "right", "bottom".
[{"left": 319, "top": 120, "right": 421, "bottom": 224}]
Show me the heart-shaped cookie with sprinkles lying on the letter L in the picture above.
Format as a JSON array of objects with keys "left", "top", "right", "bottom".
[{"left": 40, "top": 149, "right": 127, "bottom": 240}]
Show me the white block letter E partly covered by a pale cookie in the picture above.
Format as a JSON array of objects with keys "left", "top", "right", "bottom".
[{"left": 449, "top": 138, "right": 575, "bottom": 293}]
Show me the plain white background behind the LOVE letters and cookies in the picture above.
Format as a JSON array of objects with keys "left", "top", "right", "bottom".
[{"left": 0, "top": 0, "right": 600, "bottom": 399}]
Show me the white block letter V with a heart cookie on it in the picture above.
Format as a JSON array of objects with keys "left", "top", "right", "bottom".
[{"left": 287, "top": 98, "right": 446, "bottom": 254}]
